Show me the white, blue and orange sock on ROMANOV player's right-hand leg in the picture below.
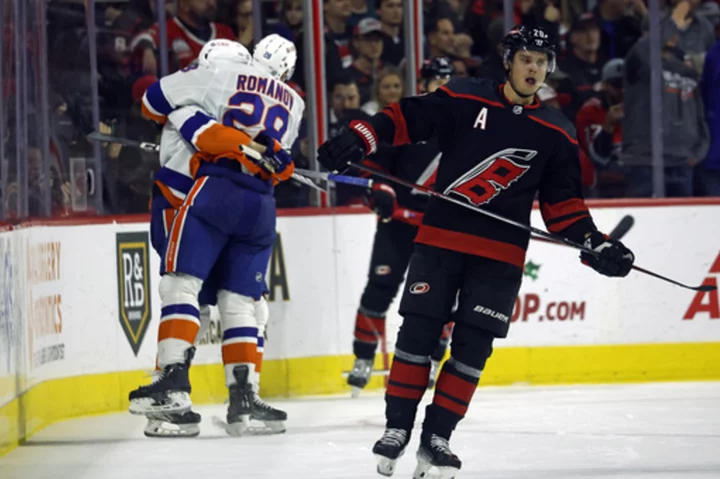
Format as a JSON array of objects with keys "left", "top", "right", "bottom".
[{"left": 218, "top": 290, "right": 258, "bottom": 387}]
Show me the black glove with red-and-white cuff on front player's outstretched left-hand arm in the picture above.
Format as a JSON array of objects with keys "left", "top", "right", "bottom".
[{"left": 317, "top": 120, "right": 377, "bottom": 173}]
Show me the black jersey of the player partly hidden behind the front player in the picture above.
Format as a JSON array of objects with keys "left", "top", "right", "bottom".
[{"left": 363, "top": 138, "right": 442, "bottom": 212}]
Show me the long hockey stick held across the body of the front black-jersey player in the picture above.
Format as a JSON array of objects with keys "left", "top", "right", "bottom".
[{"left": 349, "top": 163, "right": 717, "bottom": 291}]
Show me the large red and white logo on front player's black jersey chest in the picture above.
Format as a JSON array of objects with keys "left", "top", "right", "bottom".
[{"left": 444, "top": 148, "right": 537, "bottom": 206}]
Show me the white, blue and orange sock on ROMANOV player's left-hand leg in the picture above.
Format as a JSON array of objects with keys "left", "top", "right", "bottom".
[{"left": 156, "top": 274, "right": 202, "bottom": 369}]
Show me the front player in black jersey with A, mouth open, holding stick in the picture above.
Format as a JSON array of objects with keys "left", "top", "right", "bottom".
[{"left": 318, "top": 26, "right": 634, "bottom": 478}]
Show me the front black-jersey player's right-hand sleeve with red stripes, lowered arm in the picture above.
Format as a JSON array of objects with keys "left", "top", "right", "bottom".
[{"left": 539, "top": 123, "right": 597, "bottom": 243}]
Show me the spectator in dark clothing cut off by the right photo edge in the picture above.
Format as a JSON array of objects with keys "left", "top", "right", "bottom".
[{"left": 695, "top": 42, "right": 720, "bottom": 196}]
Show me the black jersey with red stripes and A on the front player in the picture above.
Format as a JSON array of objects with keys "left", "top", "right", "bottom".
[{"left": 371, "top": 78, "right": 595, "bottom": 268}]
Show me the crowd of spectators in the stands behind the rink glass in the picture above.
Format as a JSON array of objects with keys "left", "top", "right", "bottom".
[{"left": 3, "top": 0, "right": 720, "bottom": 218}]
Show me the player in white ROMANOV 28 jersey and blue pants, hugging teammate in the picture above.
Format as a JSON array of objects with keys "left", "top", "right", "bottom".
[{"left": 130, "top": 35, "right": 304, "bottom": 433}]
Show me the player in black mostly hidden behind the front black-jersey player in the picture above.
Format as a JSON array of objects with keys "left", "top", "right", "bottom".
[{"left": 347, "top": 57, "right": 454, "bottom": 396}]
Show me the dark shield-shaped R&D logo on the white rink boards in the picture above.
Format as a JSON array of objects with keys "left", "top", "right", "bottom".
[{"left": 115, "top": 232, "right": 152, "bottom": 356}]
